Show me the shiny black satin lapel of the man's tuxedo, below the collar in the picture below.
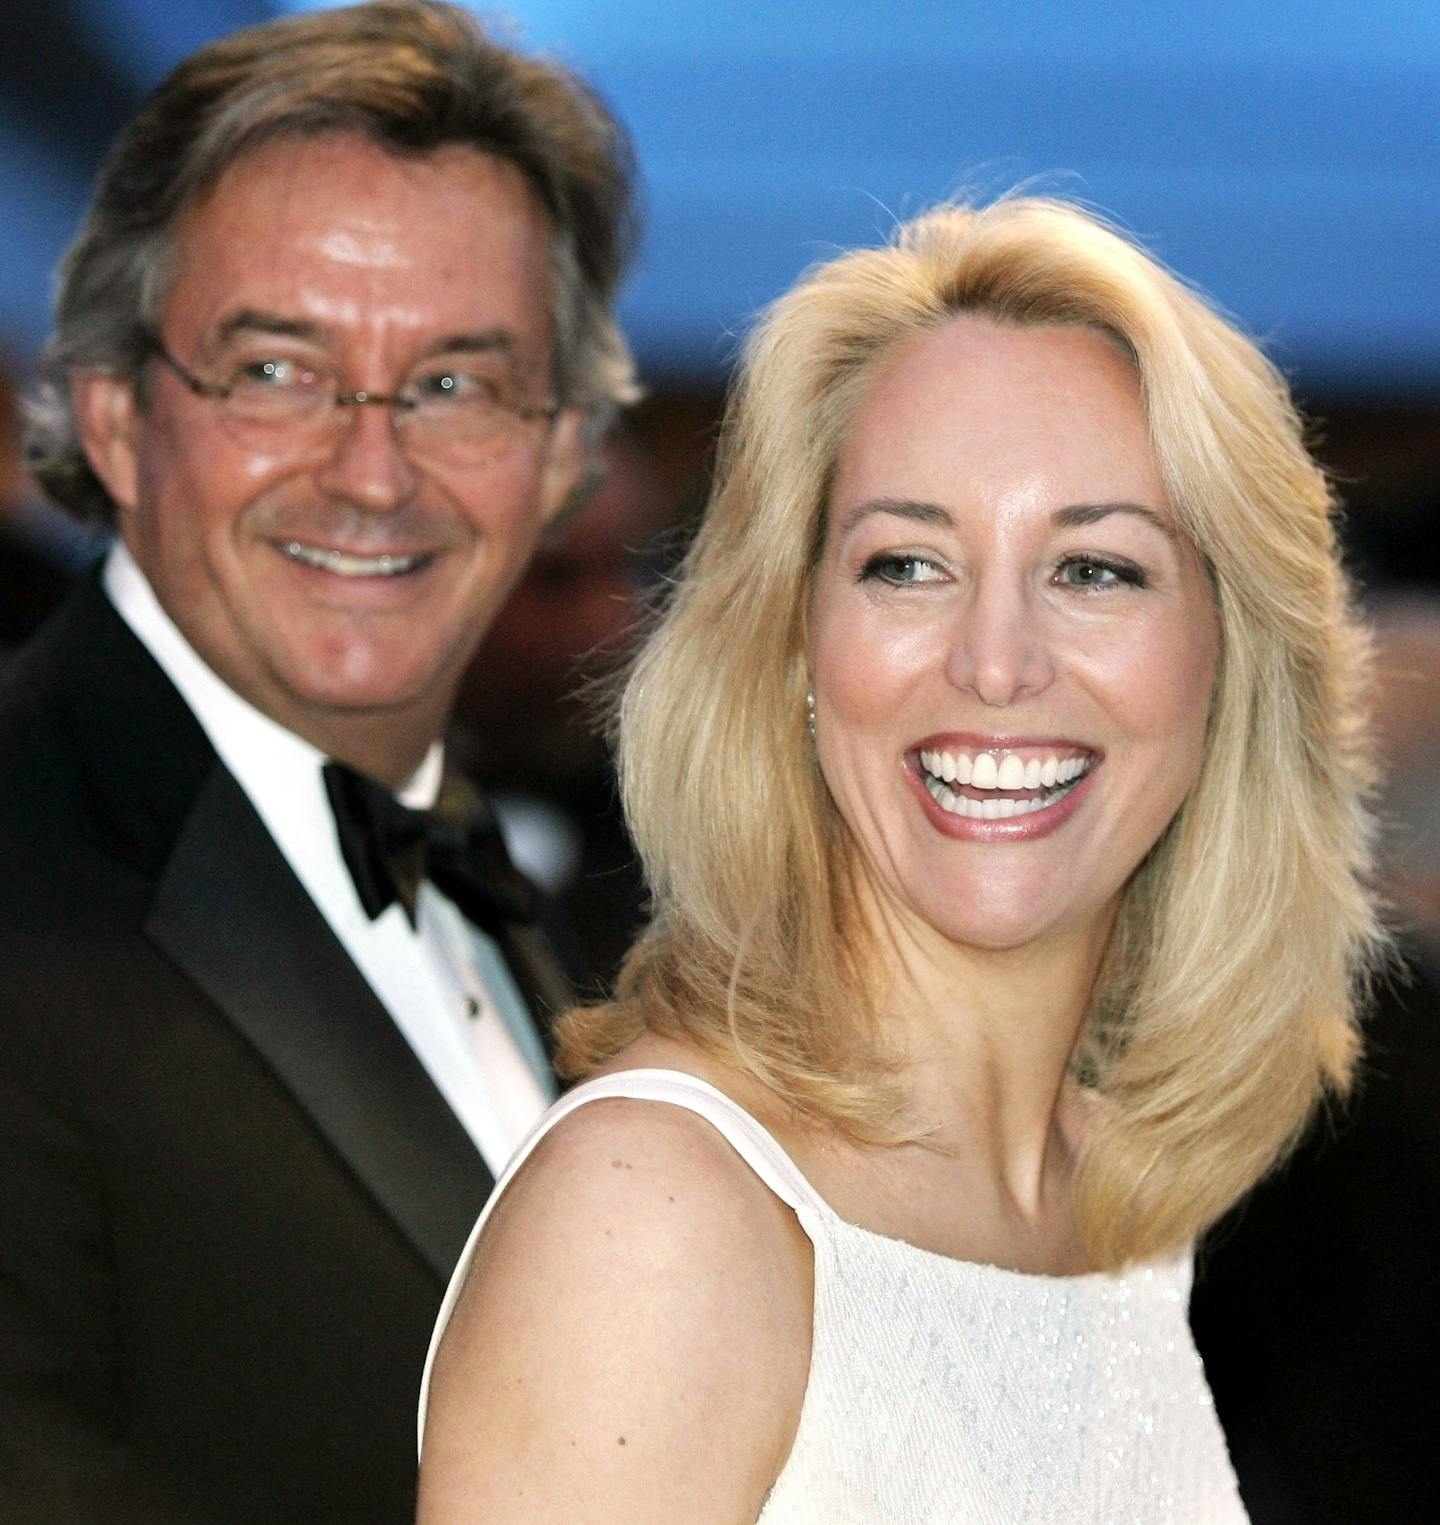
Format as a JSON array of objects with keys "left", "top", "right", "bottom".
[{"left": 145, "top": 763, "right": 493, "bottom": 1278}]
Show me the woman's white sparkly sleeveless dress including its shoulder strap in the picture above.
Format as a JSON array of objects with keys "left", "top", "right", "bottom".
[{"left": 419, "top": 1069, "right": 1246, "bottom": 1525}]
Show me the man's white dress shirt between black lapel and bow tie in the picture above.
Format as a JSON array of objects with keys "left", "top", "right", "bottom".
[{"left": 104, "top": 543, "right": 555, "bottom": 1176}]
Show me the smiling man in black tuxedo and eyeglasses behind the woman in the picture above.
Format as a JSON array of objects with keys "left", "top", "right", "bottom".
[{"left": 0, "top": 0, "right": 633, "bottom": 1525}]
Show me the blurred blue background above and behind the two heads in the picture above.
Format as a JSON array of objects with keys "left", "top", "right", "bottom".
[{"left": 0, "top": 0, "right": 1440, "bottom": 401}]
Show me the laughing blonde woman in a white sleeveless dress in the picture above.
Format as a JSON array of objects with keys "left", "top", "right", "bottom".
[{"left": 421, "top": 198, "right": 1374, "bottom": 1525}]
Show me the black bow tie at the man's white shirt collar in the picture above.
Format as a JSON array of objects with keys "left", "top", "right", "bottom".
[{"left": 323, "top": 763, "right": 535, "bottom": 932}]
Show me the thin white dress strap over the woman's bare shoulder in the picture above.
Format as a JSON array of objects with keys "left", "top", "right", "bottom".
[{"left": 419, "top": 1069, "right": 833, "bottom": 1446}]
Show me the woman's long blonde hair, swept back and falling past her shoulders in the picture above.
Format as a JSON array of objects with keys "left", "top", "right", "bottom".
[{"left": 561, "top": 197, "right": 1379, "bottom": 1266}]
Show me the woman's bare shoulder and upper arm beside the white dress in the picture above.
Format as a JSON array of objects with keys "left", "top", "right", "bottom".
[{"left": 421, "top": 1073, "right": 813, "bottom": 1525}]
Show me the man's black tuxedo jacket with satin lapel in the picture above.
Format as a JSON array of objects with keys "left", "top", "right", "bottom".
[{"left": 0, "top": 580, "right": 515, "bottom": 1525}]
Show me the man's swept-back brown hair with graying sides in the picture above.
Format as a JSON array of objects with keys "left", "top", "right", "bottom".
[{"left": 26, "top": 0, "right": 638, "bottom": 523}]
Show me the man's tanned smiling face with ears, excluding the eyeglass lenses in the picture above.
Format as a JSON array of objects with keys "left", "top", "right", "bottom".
[{"left": 76, "top": 134, "right": 580, "bottom": 776}]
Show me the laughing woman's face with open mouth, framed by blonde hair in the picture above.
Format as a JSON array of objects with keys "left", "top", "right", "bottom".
[{"left": 810, "top": 316, "right": 1219, "bottom": 949}]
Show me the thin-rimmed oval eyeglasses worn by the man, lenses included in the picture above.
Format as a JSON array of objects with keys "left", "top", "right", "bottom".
[{"left": 148, "top": 336, "right": 560, "bottom": 458}]
